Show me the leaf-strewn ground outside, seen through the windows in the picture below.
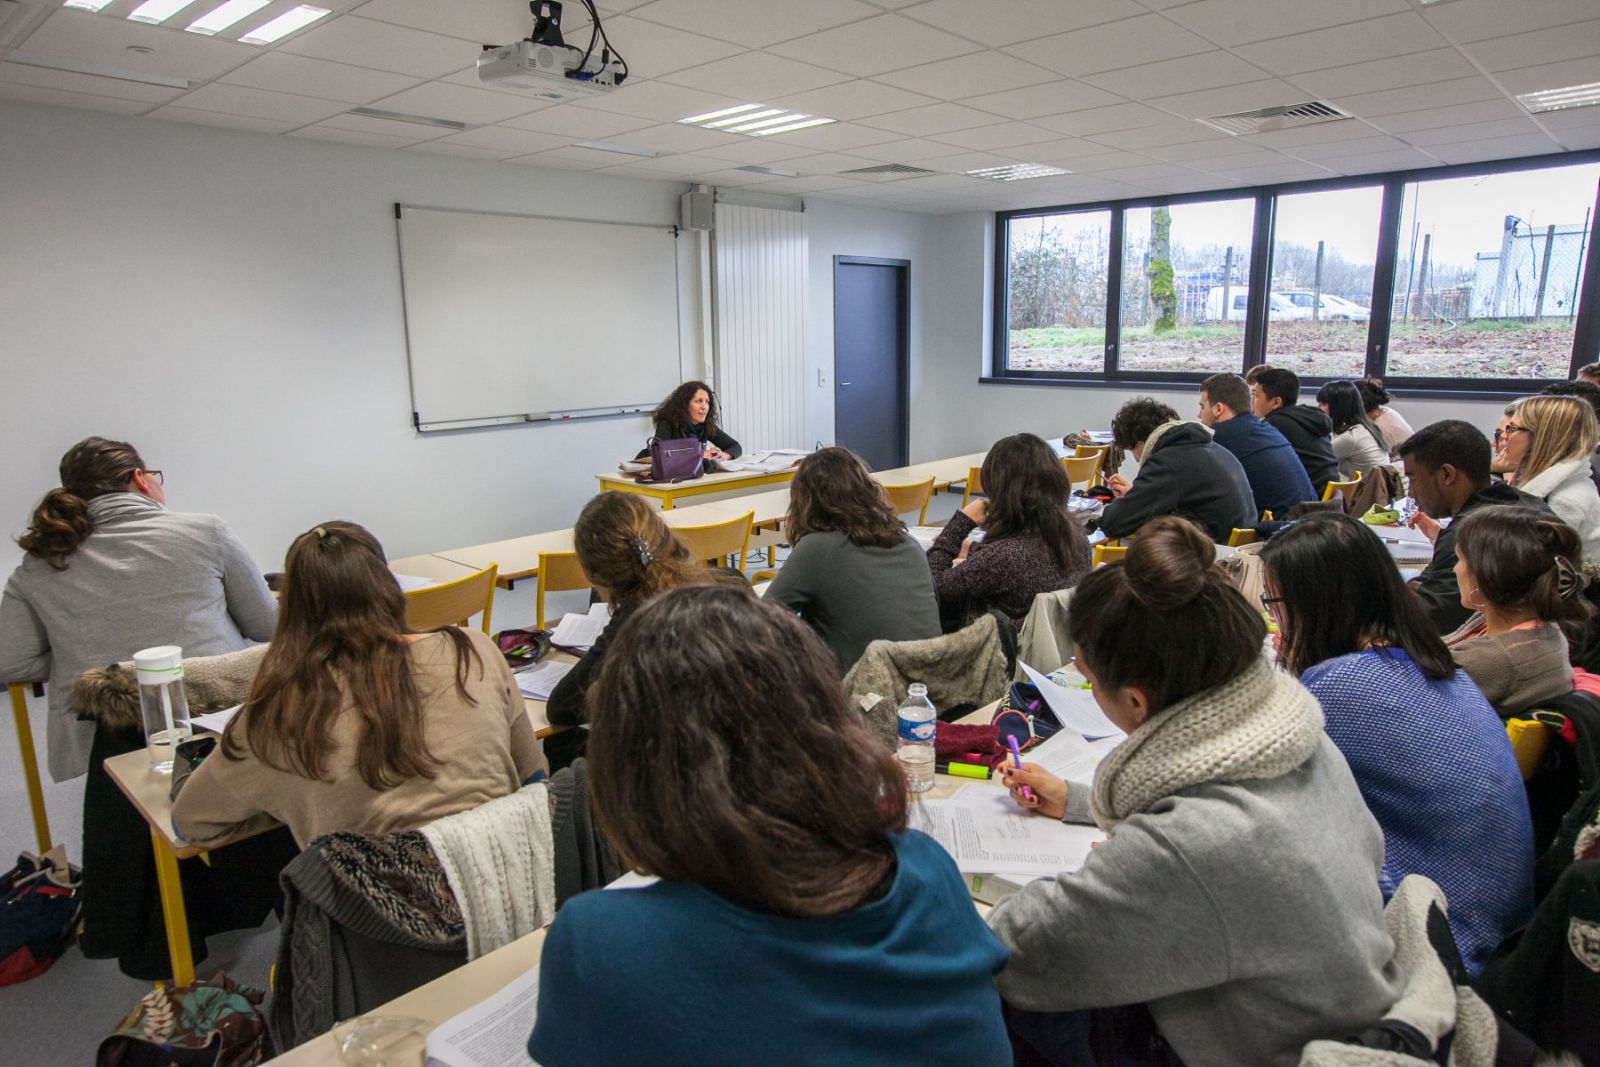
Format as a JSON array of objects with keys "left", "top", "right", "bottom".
[{"left": 1010, "top": 318, "right": 1573, "bottom": 379}]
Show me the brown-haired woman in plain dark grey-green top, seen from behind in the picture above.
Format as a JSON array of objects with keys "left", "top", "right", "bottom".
[{"left": 766, "top": 446, "right": 939, "bottom": 673}]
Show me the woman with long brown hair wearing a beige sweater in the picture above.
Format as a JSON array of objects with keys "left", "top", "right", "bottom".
[{"left": 173, "top": 522, "right": 546, "bottom": 848}]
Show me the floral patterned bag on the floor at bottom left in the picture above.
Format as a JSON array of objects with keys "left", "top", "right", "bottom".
[{"left": 94, "top": 974, "right": 272, "bottom": 1067}]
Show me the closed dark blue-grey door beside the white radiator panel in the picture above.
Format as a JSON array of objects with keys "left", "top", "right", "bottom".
[{"left": 834, "top": 256, "right": 910, "bottom": 470}]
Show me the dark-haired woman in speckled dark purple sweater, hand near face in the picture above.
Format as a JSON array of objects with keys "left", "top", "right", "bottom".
[{"left": 928, "top": 434, "right": 1090, "bottom": 630}]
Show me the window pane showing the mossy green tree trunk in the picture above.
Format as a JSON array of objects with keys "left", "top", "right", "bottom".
[{"left": 1120, "top": 198, "right": 1256, "bottom": 374}]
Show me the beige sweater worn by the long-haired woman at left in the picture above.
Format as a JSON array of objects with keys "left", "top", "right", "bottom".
[{"left": 173, "top": 630, "right": 546, "bottom": 848}]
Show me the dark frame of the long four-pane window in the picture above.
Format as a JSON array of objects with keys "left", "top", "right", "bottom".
[{"left": 979, "top": 149, "right": 1600, "bottom": 400}]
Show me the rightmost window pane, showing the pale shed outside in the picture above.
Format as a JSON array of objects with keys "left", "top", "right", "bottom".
[{"left": 1389, "top": 163, "right": 1600, "bottom": 379}]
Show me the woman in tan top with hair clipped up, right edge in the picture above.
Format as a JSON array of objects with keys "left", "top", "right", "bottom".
[{"left": 1445, "top": 507, "right": 1592, "bottom": 718}]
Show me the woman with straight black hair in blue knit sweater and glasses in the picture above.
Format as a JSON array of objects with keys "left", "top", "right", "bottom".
[{"left": 1261, "top": 507, "right": 1533, "bottom": 973}]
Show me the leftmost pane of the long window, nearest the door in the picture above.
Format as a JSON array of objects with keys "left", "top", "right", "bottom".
[{"left": 1005, "top": 211, "right": 1110, "bottom": 373}]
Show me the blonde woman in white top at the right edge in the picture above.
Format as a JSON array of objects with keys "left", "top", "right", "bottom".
[{"left": 1493, "top": 397, "right": 1600, "bottom": 560}]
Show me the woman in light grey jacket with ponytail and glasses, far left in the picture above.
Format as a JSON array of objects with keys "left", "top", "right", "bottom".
[{"left": 0, "top": 437, "right": 277, "bottom": 782}]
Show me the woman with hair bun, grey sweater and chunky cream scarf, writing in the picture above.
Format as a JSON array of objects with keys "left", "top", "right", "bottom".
[{"left": 989, "top": 517, "right": 1400, "bottom": 1067}]
